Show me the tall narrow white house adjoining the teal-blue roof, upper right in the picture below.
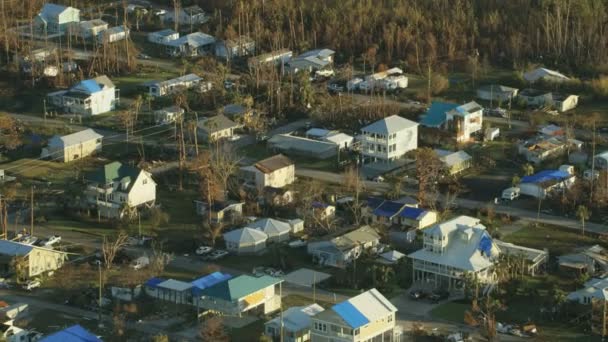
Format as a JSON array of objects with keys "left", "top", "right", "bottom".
[{"left": 446, "top": 101, "right": 483, "bottom": 142}]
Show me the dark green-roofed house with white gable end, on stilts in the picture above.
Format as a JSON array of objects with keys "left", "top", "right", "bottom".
[{"left": 85, "top": 162, "right": 156, "bottom": 218}]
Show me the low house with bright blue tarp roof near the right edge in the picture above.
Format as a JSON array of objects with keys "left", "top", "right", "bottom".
[{"left": 519, "top": 170, "right": 576, "bottom": 199}]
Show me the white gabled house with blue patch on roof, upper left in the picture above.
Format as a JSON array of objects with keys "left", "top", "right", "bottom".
[{"left": 47, "top": 75, "right": 120, "bottom": 115}]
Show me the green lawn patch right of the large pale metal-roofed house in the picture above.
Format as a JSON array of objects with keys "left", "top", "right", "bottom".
[{"left": 498, "top": 224, "right": 605, "bottom": 255}]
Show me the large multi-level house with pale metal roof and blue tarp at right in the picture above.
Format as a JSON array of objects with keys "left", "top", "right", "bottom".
[{"left": 408, "top": 216, "right": 497, "bottom": 290}]
